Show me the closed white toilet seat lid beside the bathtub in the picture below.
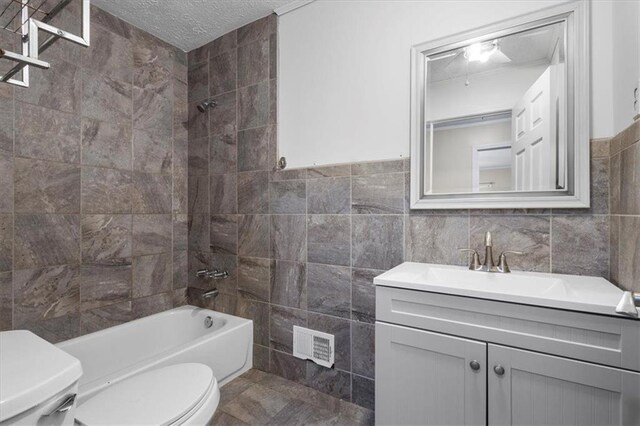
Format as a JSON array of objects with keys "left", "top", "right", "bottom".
[{"left": 76, "top": 363, "right": 219, "bottom": 426}]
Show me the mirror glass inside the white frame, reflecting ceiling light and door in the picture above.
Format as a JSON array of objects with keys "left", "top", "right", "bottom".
[{"left": 424, "top": 21, "right": 568, "bottom": 194}]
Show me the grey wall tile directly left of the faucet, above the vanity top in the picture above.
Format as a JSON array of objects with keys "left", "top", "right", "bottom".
[{"left": 405, "top": 215, "right": 468, "bottom": 265}]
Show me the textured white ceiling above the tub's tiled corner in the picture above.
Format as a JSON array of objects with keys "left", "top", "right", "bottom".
[{"left": 92, "top": 0, "right": 292, "bottom": 52}]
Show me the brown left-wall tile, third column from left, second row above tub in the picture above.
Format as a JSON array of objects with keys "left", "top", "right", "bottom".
[{"left": 80, "top": 260, "right": 131, "bottom": 312}]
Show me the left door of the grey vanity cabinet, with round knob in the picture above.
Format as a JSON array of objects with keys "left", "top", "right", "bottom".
[{"left": 376, "top": 322, "right": 487, "bottom": 425}]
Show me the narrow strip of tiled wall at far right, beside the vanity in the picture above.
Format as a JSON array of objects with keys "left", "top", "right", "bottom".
[{"left": 610, "top": 120, "right": 640, "bottom": 292}]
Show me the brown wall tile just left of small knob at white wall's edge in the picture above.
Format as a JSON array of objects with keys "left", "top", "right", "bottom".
[{"left": 238, "top": 126, "right": 275, "bottom": 172}]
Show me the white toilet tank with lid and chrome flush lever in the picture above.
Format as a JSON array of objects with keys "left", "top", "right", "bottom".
[{"left": 0, "top": 330, "right": 82, "bottom": 426}]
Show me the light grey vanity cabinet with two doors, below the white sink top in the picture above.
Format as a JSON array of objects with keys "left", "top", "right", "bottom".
[{"left": 376, "top": 287, "right": 640, "bottom": 426}]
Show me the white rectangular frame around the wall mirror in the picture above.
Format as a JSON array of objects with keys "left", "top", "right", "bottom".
[{"left": 410, "top": 0, "right": 590, "bottom": 210}]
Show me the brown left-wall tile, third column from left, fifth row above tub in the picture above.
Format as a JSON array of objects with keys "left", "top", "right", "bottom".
[{"left": 82, "top": 118, "right": 132, "bottom": 170}]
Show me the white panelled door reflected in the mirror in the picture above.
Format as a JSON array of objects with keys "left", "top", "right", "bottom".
[{"left": 511, "top": 66, "right": 556, "bottom": 191}]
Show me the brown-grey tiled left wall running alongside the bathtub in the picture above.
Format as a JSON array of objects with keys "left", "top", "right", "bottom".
[{"left": 0, "top": 6, "right": 187, "bottom": 342}]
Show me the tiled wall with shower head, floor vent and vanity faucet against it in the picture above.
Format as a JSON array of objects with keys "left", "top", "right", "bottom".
[{"left": 188, "top": 16, "right": 609, "bottom": 408}]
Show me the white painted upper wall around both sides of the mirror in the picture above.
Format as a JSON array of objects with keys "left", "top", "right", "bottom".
[{"left": 278, "top": 0, "right": 640, "bottom": 168}]
